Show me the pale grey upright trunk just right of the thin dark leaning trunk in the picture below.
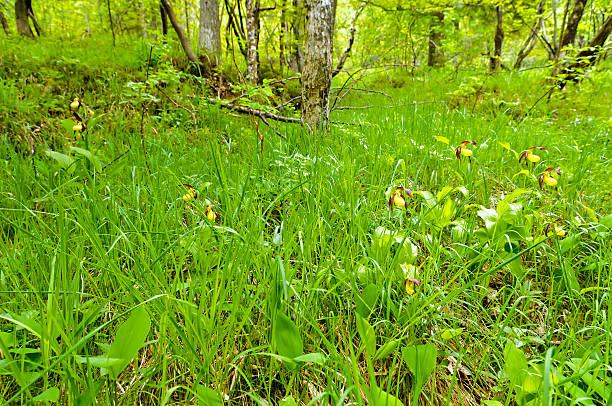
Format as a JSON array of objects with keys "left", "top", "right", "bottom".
[{"left": 198, "top": 0, "right": 221, "bottom": 67}]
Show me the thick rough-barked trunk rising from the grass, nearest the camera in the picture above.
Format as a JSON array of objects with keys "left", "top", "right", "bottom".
[{"left": 302, "top": 0, "right": 334, "bottom": 130}]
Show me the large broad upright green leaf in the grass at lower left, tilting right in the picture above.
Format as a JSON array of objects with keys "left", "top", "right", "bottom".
[{"left": 101, "top": 306, "right": 151, "bottom": 379}]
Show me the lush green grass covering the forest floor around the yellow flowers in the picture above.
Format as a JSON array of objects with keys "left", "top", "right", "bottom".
[{"left": 0, "top": 35, "right": 612, "bottom": 405}]
